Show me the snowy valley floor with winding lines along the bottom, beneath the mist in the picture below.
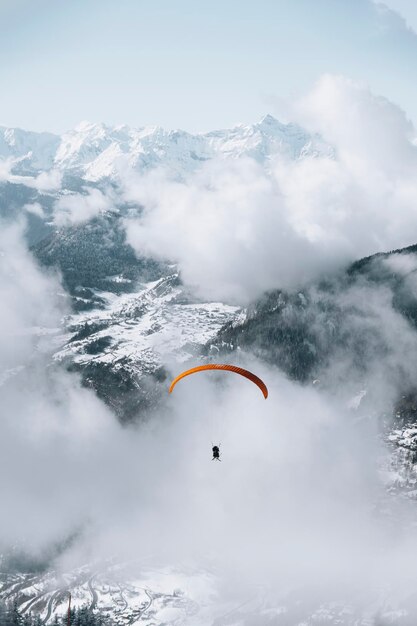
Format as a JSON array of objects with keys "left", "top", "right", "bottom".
[{"left": 0, "top": 562, "right": 414, "bottom": 626}]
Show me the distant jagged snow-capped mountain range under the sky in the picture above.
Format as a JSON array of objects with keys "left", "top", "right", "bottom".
[{"left": 0, "top": 115, "right": 333, "bottom": 181}]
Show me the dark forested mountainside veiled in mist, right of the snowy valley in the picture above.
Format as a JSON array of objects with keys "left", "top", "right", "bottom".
[{"left": 206, "top": 246, "right": 417, "bottom": 400}]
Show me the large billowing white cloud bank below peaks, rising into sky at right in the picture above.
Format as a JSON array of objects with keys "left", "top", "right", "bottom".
[{"left": 125, "top": 76, "right": 417, "bottom": 302}]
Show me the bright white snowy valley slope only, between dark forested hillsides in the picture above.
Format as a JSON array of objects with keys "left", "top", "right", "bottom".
[{"left": 55, "top": 273, "right": 238, "bottom": 374}]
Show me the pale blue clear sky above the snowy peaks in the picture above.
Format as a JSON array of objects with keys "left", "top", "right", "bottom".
[{"left": 0, "top": 0, "right": 417, "bottom": 131}]
